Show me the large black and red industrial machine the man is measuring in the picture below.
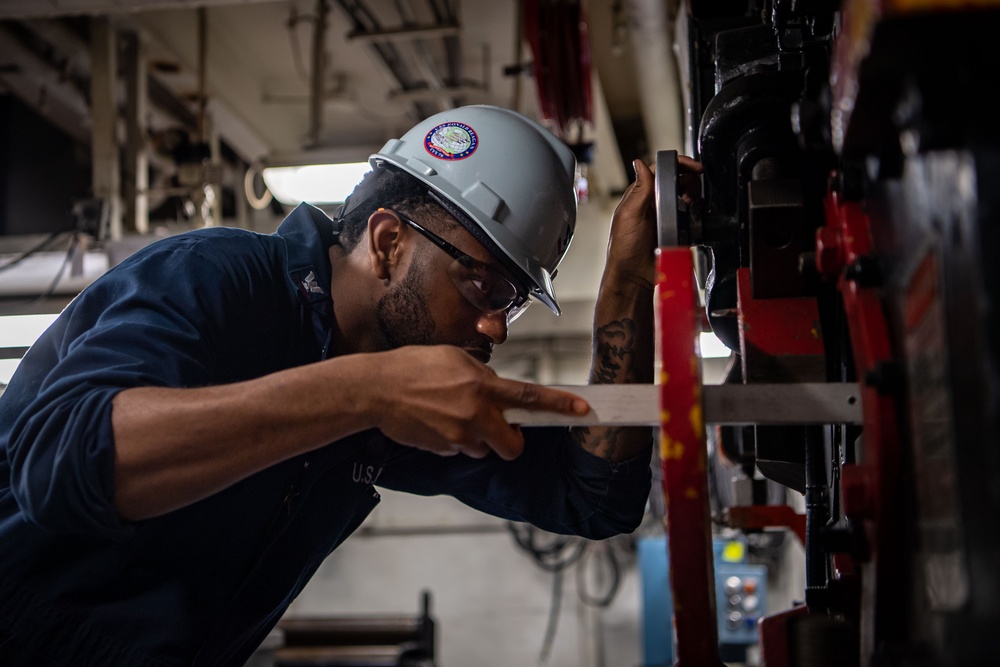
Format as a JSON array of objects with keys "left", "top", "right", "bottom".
[{"left": 516, "top": 0, "right": 1000, "bottom": 667}]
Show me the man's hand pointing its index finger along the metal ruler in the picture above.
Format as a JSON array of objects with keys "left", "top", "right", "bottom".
[{"left": 373, "top": 345, "right": 590, "bottom": 461}]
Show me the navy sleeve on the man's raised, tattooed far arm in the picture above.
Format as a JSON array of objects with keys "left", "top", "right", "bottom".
[{"left": 378, "top": 428, "right": 652, "bottom": 539}]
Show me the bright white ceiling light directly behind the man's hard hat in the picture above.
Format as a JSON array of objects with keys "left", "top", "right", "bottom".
[{"left": 261, "top": 162, "right": 371, "bottom": 206}]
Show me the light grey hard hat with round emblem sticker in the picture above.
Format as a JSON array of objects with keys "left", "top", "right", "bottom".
[{"left": 369, "top": 105, "right": 576, "bottom": 315}]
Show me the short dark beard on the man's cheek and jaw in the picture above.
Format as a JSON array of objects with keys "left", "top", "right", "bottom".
[{"left": 375, "top": 267, "right": 438, "bottom": 350}]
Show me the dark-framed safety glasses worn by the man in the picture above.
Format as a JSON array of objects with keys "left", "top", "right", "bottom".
[{"left": 396, "top": 211, "right": 531, "bottom": 325}]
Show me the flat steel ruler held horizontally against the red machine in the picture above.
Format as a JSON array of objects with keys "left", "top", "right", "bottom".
[{"left": 504, "top": 382, "right": 862, "bottom": 426}]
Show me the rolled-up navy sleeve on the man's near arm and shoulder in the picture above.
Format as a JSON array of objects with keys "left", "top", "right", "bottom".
[{"left": 0, "top": 235, "right": 274, "bottom": 539}]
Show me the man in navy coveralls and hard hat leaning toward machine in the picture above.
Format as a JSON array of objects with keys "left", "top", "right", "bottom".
[{"left": 0, "top": 107, "right": 704, "bottom": 667}]
